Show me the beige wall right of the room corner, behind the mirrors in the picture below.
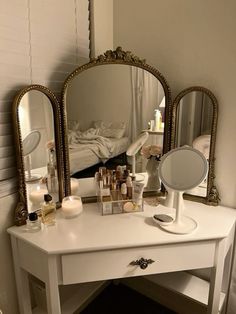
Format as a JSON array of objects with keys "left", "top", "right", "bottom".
[{"left": 114, "top": 0, "right": 236, "bottom": 207}]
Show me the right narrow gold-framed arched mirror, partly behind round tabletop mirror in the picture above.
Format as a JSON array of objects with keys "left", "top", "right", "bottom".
[{"left": 171, "top": 86, "right": 220, "bottom": 205}]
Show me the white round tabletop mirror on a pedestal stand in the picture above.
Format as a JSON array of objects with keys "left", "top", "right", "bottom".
[{"left": 159, "top": 146, "right": 208, "bottom": 234}]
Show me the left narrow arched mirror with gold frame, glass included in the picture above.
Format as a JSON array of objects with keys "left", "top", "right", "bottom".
[{"left": 13, "top": 85, "right": 64, "bottom": 225}]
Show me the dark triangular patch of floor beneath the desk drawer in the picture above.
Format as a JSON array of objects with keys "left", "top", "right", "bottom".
[{"left": 81, "top": 284, "right": 175, "bottom": 314}]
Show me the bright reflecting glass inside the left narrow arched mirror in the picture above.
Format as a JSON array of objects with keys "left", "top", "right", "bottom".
[{"left": 19, "top": 90, "right": 58, "bottom": 211}]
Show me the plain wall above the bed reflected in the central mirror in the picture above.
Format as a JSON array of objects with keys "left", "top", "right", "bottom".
[{"left": 66, "top": 64, "right": 132, "bottom": 131}]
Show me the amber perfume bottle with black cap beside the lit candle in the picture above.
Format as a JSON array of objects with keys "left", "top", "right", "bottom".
[{"left": 42, "top": 194, "right": 56, "bottom": 226}]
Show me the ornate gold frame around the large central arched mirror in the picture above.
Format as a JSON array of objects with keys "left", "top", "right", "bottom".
[{"left": 62, "top": 47, "right": 171, "bottom": 202}]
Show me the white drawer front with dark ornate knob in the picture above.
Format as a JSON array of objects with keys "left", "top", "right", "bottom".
[{"left": 61, "top": 241, "right": 215, "bottom": 284}]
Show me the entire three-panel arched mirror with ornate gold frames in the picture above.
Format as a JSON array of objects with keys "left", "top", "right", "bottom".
[{"left": 13, "top": 47, "right": 219, "bottom": 225}]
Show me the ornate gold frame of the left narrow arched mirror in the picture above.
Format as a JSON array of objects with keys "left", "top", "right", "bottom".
[{"left": 12, "top": 85, "right": 64, "bottom": 226}]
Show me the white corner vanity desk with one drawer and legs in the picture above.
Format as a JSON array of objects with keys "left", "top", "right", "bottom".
[{"left": 8, "top": 201, "right": 236, "bottom": 314}]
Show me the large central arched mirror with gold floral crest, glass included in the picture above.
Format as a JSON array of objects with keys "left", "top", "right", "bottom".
[{"left": 62, "top": 47, "right": 171, "bottom": 201}]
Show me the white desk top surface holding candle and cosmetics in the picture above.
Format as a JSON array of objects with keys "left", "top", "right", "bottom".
[{"left": 8, "top": 201, "right": 236, "bottom": 254}]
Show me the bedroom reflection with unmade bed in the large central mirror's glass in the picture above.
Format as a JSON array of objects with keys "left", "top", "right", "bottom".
[{"left": 66, "top": 64, "right": 165, "bottom": 195}]
